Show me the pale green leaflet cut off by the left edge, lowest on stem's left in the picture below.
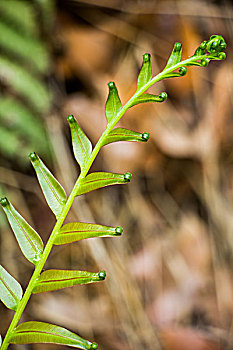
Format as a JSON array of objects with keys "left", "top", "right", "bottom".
[{"left": 0, "top": 265, "right": 23, "bottom": 311}]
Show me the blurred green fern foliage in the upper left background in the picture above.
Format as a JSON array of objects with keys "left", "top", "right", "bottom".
[{"left": 0, "top": 0, "right": 53, "bottom": 164}]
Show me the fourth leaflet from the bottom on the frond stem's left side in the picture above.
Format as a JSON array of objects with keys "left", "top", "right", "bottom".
[{"left": 67, "top": 115, "right": 92, "bottom": 168}]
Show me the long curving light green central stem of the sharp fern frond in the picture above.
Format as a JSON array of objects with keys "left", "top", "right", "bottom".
[{"left": 1, "top": 52, "right": 209, "bottom": 350}]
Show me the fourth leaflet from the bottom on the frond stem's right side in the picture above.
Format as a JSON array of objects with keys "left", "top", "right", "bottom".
[{"left": 76, "top": 172, "right": 132, "bottom": 196}]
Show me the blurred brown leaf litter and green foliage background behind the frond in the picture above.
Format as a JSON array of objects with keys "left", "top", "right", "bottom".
[{"left": 0, "top": 0, "right": 233, "bottom": 350}]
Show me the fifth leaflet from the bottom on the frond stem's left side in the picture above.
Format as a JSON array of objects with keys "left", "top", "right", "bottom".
[{"left": 105, "top": 81, "right": 121, "bottom": 123}]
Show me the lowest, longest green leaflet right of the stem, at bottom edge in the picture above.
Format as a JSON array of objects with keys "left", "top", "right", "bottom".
[{"left": 10, "top": 321, "right": 98, "bottom": 350}]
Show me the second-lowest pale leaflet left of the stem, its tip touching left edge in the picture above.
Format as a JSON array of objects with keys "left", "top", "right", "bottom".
[{"left": 0, "top": 198, "right": 43, "bottom": 265}]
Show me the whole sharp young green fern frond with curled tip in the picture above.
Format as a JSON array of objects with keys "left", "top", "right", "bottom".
[{"left": 0, "top": 35, "right": 226, "bottom": 350}]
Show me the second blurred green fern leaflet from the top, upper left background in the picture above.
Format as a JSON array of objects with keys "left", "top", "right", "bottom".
[{"left": 0, "top": 21, "right": 49, "bottom": 73}]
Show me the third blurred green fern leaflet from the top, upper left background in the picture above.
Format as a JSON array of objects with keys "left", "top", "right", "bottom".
[{"left": 0, "top": 56, "right": 51, "bottom": 113}]
